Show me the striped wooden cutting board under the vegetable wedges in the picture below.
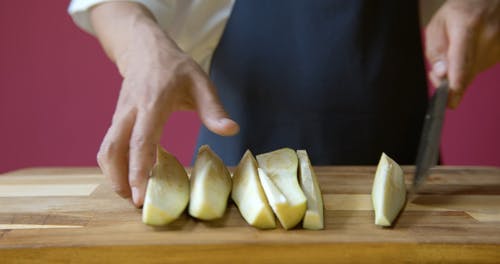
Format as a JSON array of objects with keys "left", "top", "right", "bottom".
[{"left": 0, "top": 167, "right": 500, "bottom": 264}]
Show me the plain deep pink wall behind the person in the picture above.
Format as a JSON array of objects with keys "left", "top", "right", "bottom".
[{"left": 0, "top": 0, "right": 500, "bottom": 173}]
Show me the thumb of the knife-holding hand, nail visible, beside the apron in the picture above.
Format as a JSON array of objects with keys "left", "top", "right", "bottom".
[{"left": 425, "top": 13, "right": 449, "bottom": 87}]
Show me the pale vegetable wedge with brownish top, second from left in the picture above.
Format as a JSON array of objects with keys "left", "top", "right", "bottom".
[{"left": 189, "top": 145, "right": 232, "bottom": 220}]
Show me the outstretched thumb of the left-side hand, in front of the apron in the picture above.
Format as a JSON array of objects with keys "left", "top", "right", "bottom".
[{"left": 193, "top": 76, "right": 239, "bottom": 136}]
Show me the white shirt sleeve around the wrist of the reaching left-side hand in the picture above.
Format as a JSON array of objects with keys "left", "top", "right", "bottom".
[{"left": 68, "top": 0, "right": 235, "bottom": 72}]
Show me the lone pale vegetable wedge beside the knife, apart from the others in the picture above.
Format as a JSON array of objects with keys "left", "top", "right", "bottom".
[{"left": 372, "top": 153, "right": 406, "bottom": 226}]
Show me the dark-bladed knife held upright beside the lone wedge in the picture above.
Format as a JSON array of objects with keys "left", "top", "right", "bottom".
[{"left": 410, "top": 80, "right": 449, "bottom": 194}]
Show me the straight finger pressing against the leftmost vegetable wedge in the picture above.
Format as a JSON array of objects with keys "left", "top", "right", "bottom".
[{"left": 128, "top": 110, "right": 165, "bottom": 207}]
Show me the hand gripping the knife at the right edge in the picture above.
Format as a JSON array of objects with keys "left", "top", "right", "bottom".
[{"left": 426, "top": 0, "right": 500, "bottom": 108}]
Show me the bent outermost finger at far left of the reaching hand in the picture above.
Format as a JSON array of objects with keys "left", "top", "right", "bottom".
[{"left": 97, "top": 112, "right": 135, "bottom": 198}]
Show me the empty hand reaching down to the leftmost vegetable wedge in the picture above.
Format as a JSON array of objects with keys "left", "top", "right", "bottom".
[{"left": 92, "top": 2, "right": 239, "bottom": 207}]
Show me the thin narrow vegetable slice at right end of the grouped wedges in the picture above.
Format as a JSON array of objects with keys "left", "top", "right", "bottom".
[{"left": 297, "top": 150, "right": 324, "bottom": 230}]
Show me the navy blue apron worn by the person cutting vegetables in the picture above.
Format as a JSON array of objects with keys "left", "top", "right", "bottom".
[{"left": 193, "top": 0, "right": 427, "bottom": 165}]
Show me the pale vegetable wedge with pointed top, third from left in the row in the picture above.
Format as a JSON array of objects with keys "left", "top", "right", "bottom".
[{"left": 231, "top": 150, "right": 276, "bottom": 229}]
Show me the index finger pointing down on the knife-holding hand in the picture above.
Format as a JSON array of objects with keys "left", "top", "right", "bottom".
[{"left": 448, "top": 21, "right": 476, "bottom": 108}]
